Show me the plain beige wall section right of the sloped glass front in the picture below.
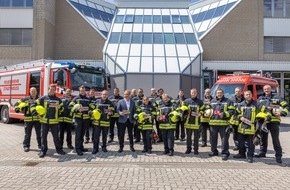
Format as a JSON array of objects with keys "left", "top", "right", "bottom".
[{"left": 201, "top": 0, "right": 264, "bottom": 61}]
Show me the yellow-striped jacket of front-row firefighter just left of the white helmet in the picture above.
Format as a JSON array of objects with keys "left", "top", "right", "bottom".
[{"left": 184, "top": 97, "right": 204, "bottom": 129}]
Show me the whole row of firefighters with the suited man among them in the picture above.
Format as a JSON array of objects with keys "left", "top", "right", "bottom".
[{"left": 15, "top": 85, "right": 289, "bottom": 163}]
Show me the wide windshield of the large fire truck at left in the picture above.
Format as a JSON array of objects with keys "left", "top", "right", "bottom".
[{"left": 71, "top": 69, "right": 105, "bottom": 91}]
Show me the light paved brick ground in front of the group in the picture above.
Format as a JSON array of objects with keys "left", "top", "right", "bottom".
[{"left": 0, "top": 118, "right": 290, "bottom": 190}]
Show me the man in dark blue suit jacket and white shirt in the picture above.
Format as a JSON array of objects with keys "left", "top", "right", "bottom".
[{"left": 117, "top": 90, "right": 136, "bottom": 153}]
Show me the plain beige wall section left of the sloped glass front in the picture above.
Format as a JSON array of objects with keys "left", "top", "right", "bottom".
[{"left": 54, "top": 0, "right": 105, "bottom": 59}]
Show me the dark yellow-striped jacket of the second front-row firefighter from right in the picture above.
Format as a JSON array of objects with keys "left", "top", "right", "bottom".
[{"left": 236, "top": 100, "right": 271, "bottom": 135}]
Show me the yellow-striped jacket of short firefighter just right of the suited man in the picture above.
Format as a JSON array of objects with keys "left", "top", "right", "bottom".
[{"left": 134, "top": 102, "right": 157, "bottom": 131}]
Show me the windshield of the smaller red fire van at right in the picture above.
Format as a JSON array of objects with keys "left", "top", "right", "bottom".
[{"left": 211, "top": 84, "right": 244, "bottom": 98}]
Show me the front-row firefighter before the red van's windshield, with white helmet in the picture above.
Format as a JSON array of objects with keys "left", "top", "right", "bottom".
[{"left": 208, "top": 89, "right": 234, "bottom": 160}]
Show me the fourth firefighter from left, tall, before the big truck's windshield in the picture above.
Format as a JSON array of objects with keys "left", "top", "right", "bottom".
[{"left": 69, "top": 85, "right": 93, "bottom": 156}]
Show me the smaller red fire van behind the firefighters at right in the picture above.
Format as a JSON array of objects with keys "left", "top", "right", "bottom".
[{"left": 211, "top": 72, "right": 279, "bottom": 100}]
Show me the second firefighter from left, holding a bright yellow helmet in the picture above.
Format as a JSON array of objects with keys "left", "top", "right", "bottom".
[{"left": 31, "top": 85, "right": 65, "bottom": 158}]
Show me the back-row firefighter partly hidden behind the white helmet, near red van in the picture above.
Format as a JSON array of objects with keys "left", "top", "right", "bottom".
[{"left": 200, "top": 88, "right": 213, "bottom": 147}]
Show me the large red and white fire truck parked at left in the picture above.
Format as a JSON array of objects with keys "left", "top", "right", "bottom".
[{"left": 0, "top": 60, "right": 110, "bottom": 123}]
